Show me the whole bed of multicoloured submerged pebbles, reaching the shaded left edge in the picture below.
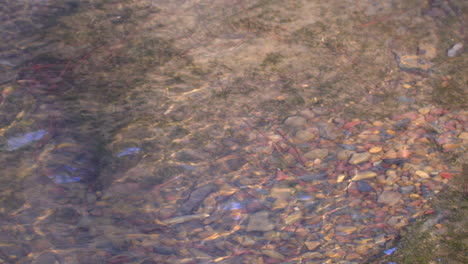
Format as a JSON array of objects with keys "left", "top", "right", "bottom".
[{"left": 0, "top": 63, "right": 468, "bottom": 264}]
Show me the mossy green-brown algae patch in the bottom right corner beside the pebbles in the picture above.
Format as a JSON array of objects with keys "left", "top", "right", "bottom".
[{"left": 373, "top": 164, "right": 468, "bottom": 264}]
